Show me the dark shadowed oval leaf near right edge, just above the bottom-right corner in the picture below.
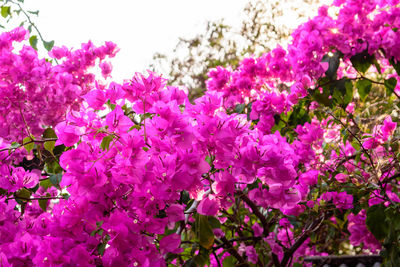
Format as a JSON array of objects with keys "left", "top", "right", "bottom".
[{"left": 366, "top": 205, "right": 389, "bottom": 240}]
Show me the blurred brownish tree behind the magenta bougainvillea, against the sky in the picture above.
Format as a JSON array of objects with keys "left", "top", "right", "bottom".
[{"left": 150, "top": 0, "right": 321, "bottom": 99}]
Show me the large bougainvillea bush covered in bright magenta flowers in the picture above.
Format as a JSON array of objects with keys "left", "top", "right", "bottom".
[{"left": 0, "top": 0, "right": 400, "bottom": 266}]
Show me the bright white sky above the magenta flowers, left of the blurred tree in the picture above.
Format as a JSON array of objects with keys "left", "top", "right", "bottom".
[{"left": 24, "top": 0, "right": 247, "bottom": 80}]
